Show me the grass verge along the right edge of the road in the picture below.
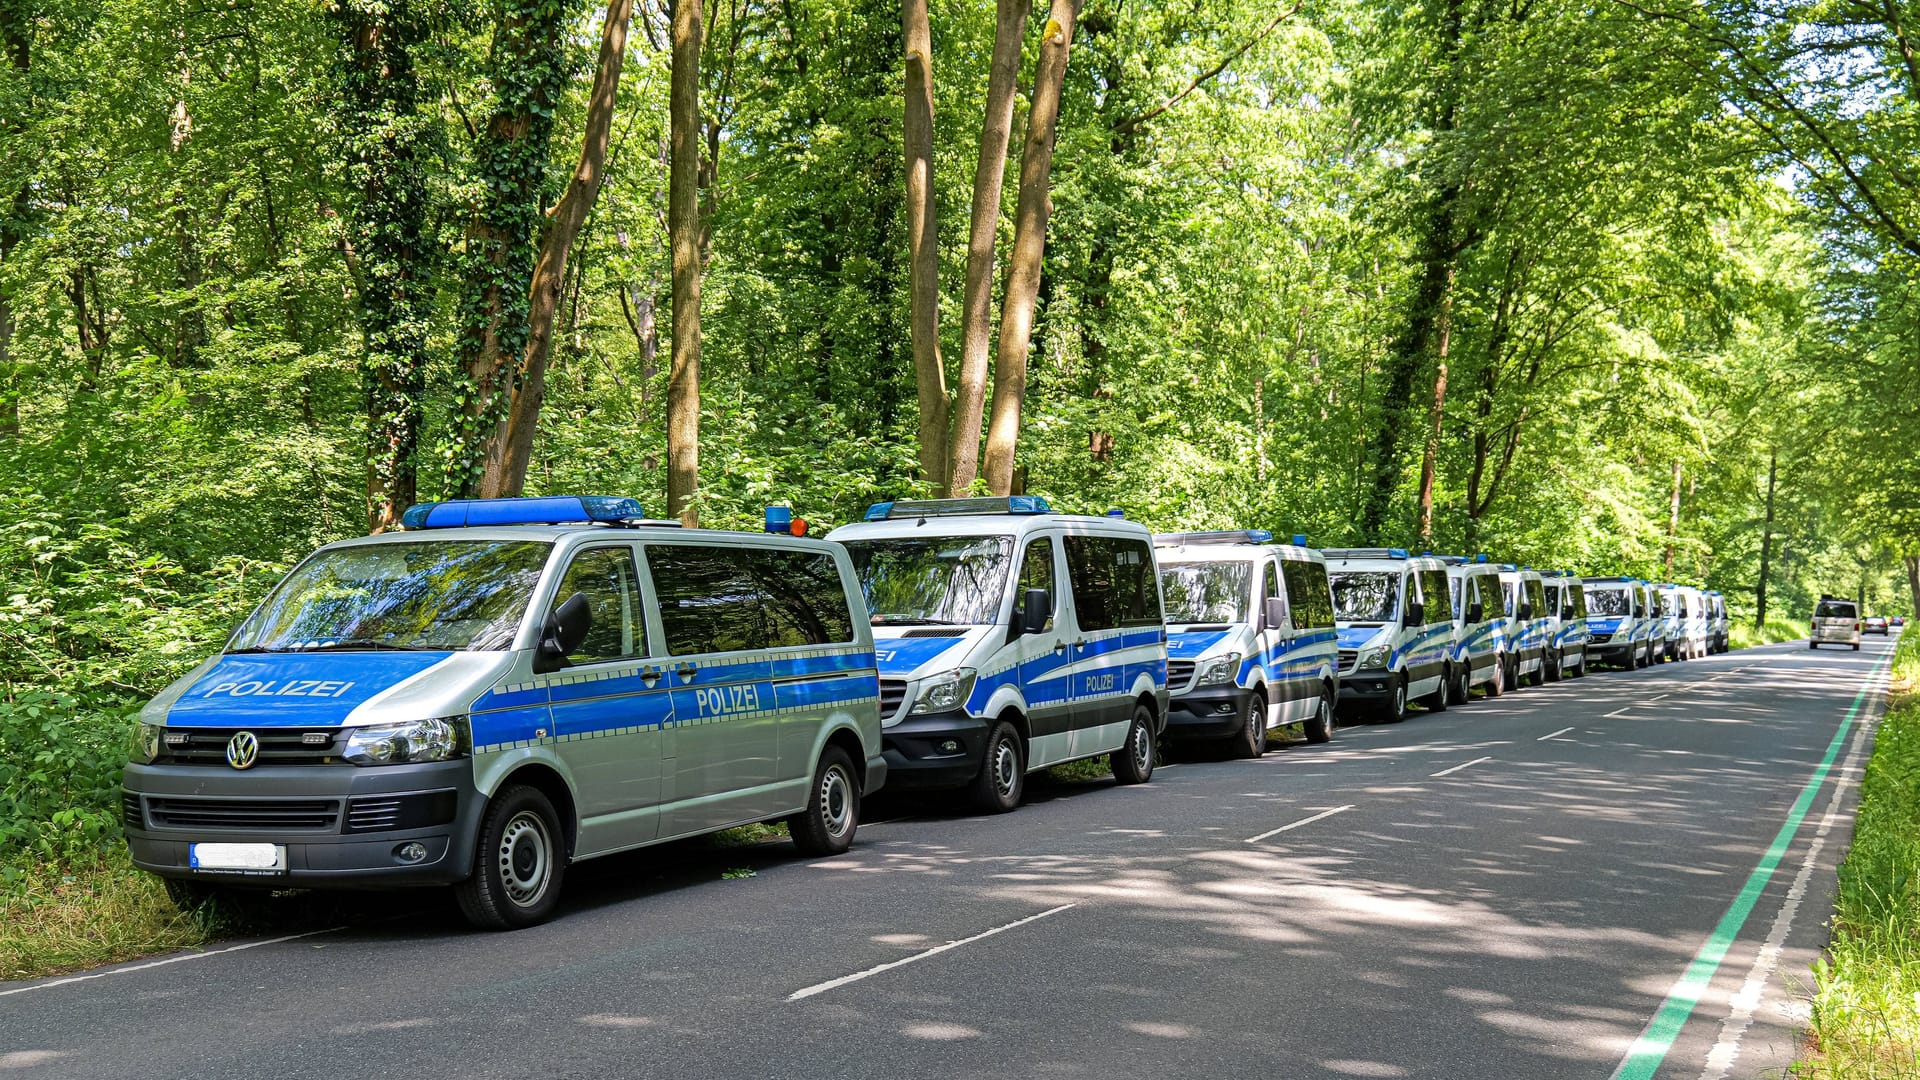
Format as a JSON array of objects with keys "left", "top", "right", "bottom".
[{"left": 1793, "top": 634, "right": 1920, "bottom": 1080}]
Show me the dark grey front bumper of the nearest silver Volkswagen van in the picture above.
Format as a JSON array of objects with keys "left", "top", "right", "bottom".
[{"left": 121, "top": 757, "right": 486, "bottom": 888}]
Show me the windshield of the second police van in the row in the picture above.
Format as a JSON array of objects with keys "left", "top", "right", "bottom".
[{"left": 847, "top": 536, "right": 1014, "bottom": 626}]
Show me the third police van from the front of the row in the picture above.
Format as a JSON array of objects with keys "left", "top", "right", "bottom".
[{"left": 1154, "top": 528, "right": 1340, "bottom": 757}]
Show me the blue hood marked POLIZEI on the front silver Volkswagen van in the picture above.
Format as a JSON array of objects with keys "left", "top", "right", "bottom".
[{"left": 150, "top": 651, "right": 458, "bottom": 728}]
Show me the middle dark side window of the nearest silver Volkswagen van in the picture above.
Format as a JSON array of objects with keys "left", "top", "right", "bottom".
[{"left": 647, "top": 544, "right": 768, "bottom": 655}]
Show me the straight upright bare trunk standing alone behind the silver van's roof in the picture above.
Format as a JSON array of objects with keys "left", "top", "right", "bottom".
[{"left": 666, "top": 0, "right": 705, "bottom": 528}]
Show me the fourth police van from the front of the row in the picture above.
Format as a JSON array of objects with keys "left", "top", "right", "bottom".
[{"left": 1323, "top": 548, "right": 1453, "bottom": 723}]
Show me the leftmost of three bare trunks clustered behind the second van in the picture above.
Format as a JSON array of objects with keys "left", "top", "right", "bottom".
[{"left": 900, "top": 0, "right": 947, "bottom": 492}]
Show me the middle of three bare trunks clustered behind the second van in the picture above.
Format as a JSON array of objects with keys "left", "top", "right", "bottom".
[{"left": 947, "top": 0, "right": 1031, "bottom": 496}]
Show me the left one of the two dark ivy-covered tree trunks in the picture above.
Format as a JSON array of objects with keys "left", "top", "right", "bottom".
[{"left": 328, "top": 0, "right": 436, "bottom": 532}]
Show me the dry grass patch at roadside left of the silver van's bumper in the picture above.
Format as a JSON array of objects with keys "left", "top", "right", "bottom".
[{"left": 0, "top": 851, "right": 213, "bottom": 978}]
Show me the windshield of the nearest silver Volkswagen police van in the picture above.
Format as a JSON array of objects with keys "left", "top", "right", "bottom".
[{"left": 227, "top": 540, "right": 553, "bottom": 653}]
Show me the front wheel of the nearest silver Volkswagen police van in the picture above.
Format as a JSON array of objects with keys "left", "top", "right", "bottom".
[{"left": 453, "top": 784, "right": 566, "bottom": 930}]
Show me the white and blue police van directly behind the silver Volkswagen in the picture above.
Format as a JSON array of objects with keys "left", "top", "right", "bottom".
[{"left": 828, "top": 496, "right": 1167, "bottom": 813}]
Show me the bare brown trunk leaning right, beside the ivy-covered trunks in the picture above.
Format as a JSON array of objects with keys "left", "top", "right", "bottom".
[{"left": 480, "top": 0, "right": 634, "bottom": 498}]
